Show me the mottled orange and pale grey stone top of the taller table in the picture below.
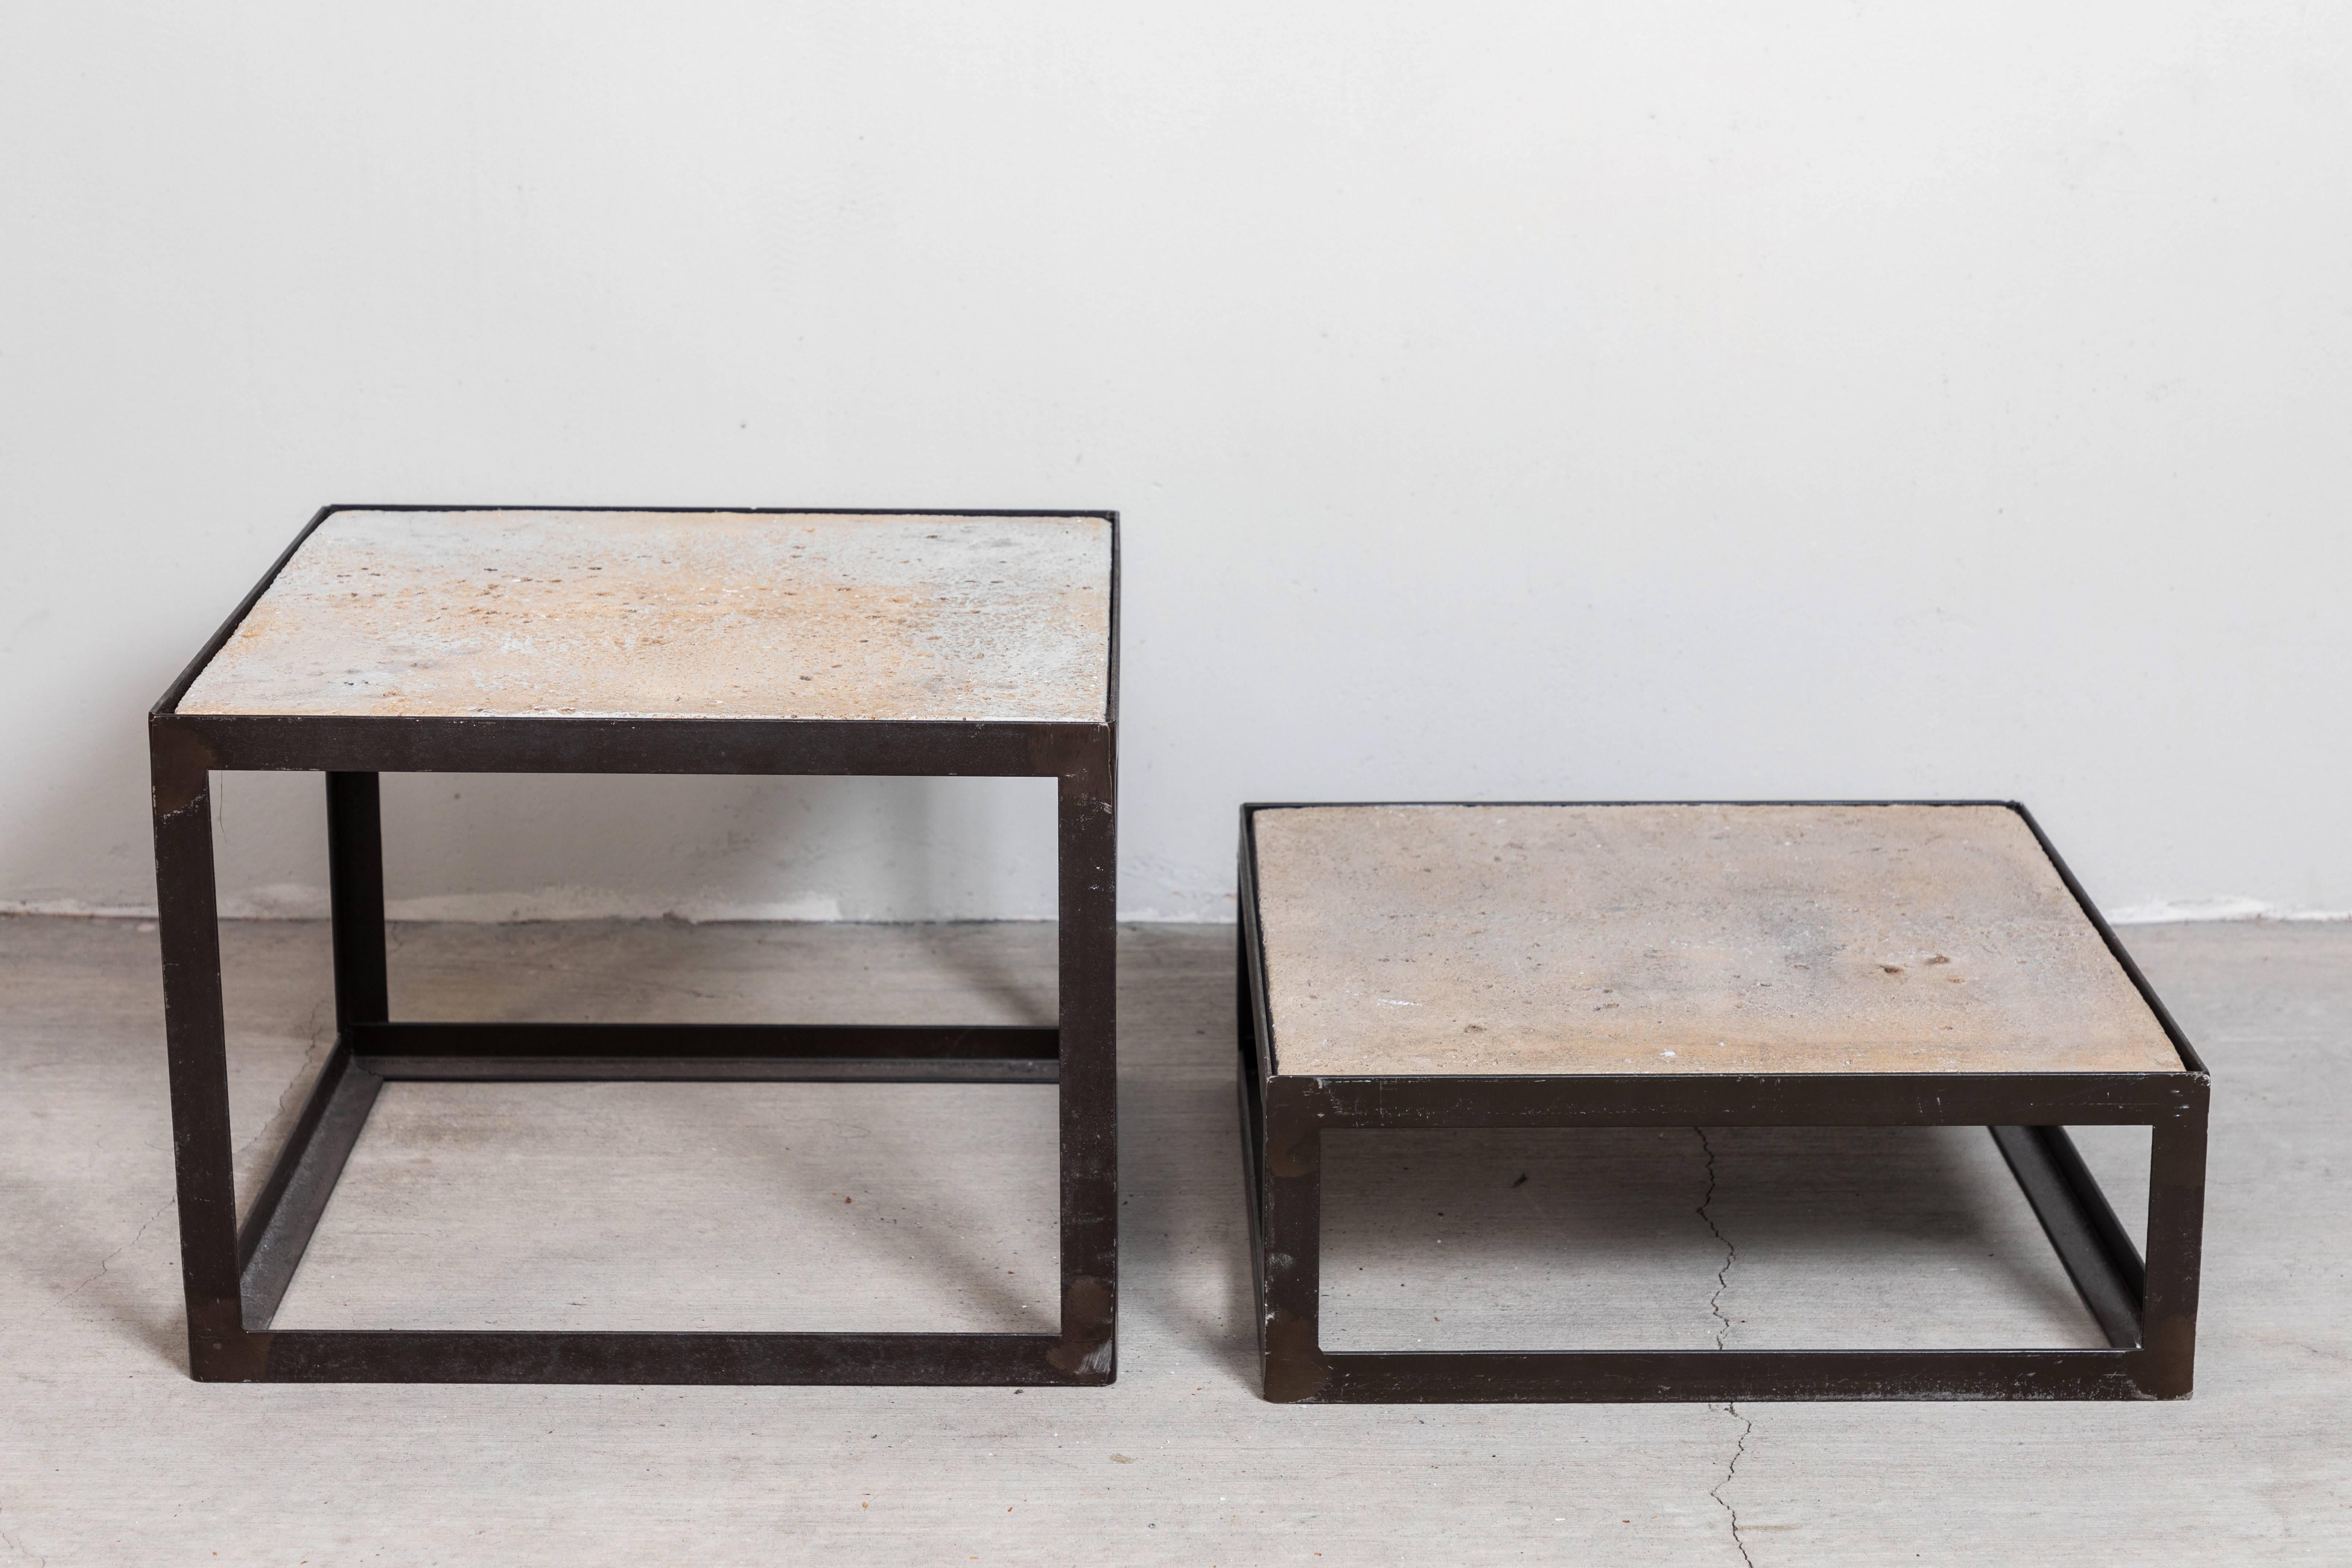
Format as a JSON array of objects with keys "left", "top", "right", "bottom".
[{"left": 179, "top": 510, "right": 1110, "bottom": 724}]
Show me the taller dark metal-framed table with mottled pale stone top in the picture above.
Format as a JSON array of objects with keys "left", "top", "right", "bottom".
[{"left": 148, "top": 508, "right": 1119, "bottom": 1385}]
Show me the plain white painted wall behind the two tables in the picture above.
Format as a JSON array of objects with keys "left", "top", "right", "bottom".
[{"left": 0, "top": 0, "right": 2352, "bottom": 919}]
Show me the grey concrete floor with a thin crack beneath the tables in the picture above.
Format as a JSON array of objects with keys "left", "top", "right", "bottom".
[{"left": 0, "top": 919, "right": 2352, "bottom": 1568}]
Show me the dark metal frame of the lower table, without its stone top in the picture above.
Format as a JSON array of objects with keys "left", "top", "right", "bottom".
[{"left": 1237, "top": 802, "right": 2211, "bottom": 1403}]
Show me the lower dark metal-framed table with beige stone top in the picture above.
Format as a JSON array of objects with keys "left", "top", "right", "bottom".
[{"left": 1237, "top": 802, "right": 2211, "bottom": 1401}]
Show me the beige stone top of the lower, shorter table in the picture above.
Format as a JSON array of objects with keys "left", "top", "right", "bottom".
[{"left": 1251, "top": 806, "right": 2185, "bottom": 1077}]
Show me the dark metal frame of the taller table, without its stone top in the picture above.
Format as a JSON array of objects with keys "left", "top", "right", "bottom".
[{"left": 148, "top": 506, "right": 1119, "bottom": 1385}]
